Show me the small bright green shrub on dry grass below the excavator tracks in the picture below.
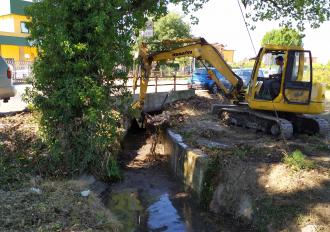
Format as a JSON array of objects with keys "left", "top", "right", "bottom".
[{"left": 283, "top": 150, "right": 315, "bottom": 170}]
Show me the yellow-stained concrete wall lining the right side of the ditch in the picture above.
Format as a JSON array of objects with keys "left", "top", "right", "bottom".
[{"left": 163, "top": 129, "right": 208, "bottom": 198}]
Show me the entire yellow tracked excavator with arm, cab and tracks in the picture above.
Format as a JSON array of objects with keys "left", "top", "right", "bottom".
[{"left": 133, "top": 38, "right": 330, "bottom": 138}]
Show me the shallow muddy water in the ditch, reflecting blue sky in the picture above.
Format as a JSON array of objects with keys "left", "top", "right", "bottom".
[{"left": 107, "top": 131, "right": 235, "bottom": 232}]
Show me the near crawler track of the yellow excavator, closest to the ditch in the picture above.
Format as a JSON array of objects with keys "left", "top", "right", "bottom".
[{"left": 218, "top": 107, "right": 293, "bottom": 139}]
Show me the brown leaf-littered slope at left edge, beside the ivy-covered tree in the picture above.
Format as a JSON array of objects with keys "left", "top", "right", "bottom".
[{"left": 0, "top": 113, "right": 44, "bottom": 190}]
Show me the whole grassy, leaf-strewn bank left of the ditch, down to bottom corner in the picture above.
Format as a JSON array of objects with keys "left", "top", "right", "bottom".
[{"left": 0, "top": 113, "right": 122, "bottom": 231}]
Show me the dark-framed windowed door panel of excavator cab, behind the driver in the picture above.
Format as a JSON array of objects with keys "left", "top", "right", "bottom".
[{"left": 283, "top": 50, "right": 313, "bottom": 105}]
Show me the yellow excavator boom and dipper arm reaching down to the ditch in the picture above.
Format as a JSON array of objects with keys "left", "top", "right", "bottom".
[{"left": 133, "top": 38, "right": 244, "bottom": 109}]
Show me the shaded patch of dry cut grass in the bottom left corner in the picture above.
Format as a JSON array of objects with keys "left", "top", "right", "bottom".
[{"left": 0, "top": 180, "right": 122, "bottom": 232}]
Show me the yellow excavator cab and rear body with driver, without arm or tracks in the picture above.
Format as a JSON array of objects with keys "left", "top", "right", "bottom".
[{"left": 246, "top": 46, "right": 325, "bottom": 114}]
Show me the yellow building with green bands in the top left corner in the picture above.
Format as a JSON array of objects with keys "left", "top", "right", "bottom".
[{"left": 0, "top": 0, "right": 37, "bottom": 61}]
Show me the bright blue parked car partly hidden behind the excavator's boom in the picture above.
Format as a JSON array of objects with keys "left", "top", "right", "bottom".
[{"left": 188, "top": 68, "right": 231, "bottom": 93}]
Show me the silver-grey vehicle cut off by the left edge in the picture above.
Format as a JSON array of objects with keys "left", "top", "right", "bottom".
[{"left": 0, "top": 56, "right": 16, "bottom": 102}]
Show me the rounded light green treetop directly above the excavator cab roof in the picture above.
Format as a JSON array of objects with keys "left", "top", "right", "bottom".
[{"left": 261, "top": 28, "right": 303, "bottom": 46}]
